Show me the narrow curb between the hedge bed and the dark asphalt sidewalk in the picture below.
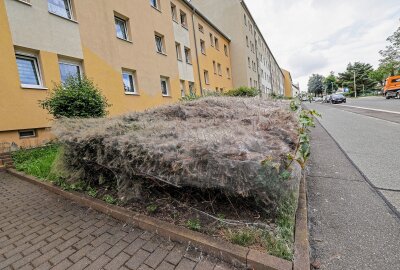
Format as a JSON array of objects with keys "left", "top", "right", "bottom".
[{"left": 293, "top": 173, "right": 310, "bottom": 270}]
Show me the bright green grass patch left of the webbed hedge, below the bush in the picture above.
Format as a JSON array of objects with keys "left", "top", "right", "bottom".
[{"left": 12, "top": 144, "right": 59, "bottom": 180}]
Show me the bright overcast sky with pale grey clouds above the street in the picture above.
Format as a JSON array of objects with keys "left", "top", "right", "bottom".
[{"left": 245, "top": 0, "right": 400, "bottom": 91}]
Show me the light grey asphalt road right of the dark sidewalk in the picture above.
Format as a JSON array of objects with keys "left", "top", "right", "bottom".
[{"left": 307, "top": 97, "right": 400, "bottom": 215}]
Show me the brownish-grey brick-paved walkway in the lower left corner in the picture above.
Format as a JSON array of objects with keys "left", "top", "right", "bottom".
[{"left": 0, "top": 172, "right": 238, "bottom": 270}]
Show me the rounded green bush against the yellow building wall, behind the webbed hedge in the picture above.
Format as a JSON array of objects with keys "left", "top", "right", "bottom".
[{"left": 40, "top": 76, "right": 110, "bottom": 119}]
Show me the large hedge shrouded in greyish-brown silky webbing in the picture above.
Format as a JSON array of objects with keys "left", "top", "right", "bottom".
[{"left": 54, "top": 97, "right": 299, "bottom": 212}]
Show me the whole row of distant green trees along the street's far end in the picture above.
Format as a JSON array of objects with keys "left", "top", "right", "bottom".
[{"left": 308, "top": 24, "right": 400, "bottom": 96}]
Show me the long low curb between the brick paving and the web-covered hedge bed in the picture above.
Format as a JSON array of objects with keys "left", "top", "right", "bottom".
[{"left": 7, "top": 169, "right": 294, "bottom": 270}]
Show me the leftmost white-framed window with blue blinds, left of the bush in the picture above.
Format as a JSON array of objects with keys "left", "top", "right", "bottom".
[{"left": 16, "top": 54, "right": 42, "bottom": 86}]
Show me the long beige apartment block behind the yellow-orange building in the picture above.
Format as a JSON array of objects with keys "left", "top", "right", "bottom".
[{"left": 191, "top": 0, "right": 284, "bottom": 95}]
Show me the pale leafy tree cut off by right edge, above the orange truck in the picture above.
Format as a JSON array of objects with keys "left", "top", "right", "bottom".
[{"left": 379, "top": 27, "right": 400, "bottom": 76}]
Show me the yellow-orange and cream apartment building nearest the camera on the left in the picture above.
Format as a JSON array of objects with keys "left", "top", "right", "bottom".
[{"left": 0, "top": 0, "right": 233, "bottom": 147}]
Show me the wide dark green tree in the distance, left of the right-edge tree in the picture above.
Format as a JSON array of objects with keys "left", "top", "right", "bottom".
[{"left": 338, "top": 62, "right": 377, "bottom": 94}]
